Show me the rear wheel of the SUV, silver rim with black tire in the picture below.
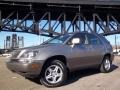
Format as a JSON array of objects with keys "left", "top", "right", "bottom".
[{"left": 100, "top": 56, "right": 112, "bottom": 73}]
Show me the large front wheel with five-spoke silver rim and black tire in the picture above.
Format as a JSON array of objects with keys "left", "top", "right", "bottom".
[{"left": 40, "top": 60, "right": 67, "bottom": 87}]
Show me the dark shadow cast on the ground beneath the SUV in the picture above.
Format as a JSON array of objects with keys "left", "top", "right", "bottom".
[{"left": 26, "top": 65, "right": 118, "bottom": 86}]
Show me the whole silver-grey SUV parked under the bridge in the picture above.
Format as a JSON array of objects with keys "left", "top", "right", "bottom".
[{"left": 6, "top": 32, "right": 114, "bottom": 87}]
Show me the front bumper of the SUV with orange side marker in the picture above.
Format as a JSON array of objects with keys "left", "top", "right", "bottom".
[{"left": 6, "top": 60, "right": 43, "bottom": 78}]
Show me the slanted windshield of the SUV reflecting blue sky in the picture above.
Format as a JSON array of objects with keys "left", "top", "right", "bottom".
[{"left": 43, "top": 34, "right": 70, "bottom": 44}]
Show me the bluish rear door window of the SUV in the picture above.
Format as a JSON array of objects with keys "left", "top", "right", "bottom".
[{"left": 87, "top": 34, "right": 102, "bottom": 45}]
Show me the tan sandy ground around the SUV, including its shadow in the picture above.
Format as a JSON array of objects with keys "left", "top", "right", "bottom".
[{"left": 0, "top": 56, "right": 120, "bottom": 90}]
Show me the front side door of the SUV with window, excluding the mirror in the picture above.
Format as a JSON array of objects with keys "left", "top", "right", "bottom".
[{"left": 69, "top": 33, "right": 88, "bottom": 69}]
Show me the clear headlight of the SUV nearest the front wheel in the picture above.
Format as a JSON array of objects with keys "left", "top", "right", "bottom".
[{"left": 19, "top": 50, "right": 39, "bottom": 63}]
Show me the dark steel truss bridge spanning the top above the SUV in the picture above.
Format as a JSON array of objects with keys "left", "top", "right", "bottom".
[{"left": 0, "top": 0, "right": 120, "bottom": 37}]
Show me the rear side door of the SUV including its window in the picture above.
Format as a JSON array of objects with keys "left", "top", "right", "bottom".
[{"left": 86, "top": 34, "right": 104, "bottom": 65}]
